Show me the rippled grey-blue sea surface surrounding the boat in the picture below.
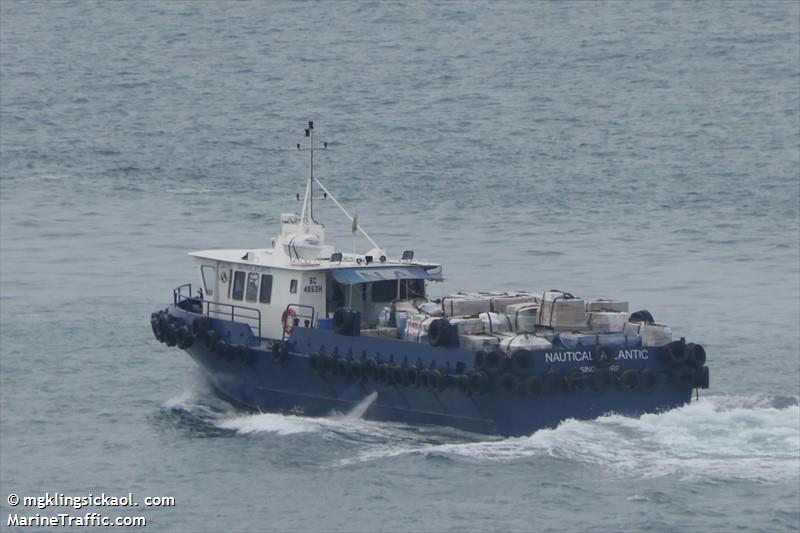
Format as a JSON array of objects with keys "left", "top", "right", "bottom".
[{"left": 0, "top": 0, "right": 800, "bottom": 532}]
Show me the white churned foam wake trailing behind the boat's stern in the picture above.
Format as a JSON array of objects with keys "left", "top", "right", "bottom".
[{"left": 341, "top": 397, "right": 800, "bottom": 481}]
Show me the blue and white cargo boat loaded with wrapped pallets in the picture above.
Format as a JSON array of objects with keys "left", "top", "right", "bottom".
[{"left": 150, "top": 122, "right": 709, "bottom": 436}]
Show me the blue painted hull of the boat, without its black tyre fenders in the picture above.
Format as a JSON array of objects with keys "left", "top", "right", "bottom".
[{"left": 158, "top": 306, "right": 707, "bottom": 436}]
